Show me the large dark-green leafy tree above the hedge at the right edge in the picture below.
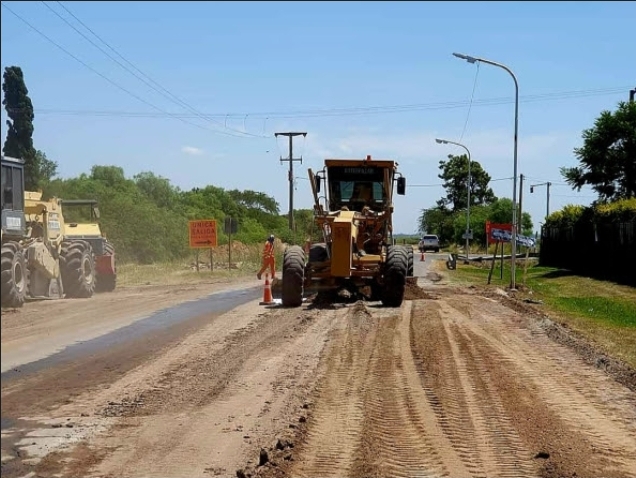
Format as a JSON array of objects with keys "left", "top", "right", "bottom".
[{"left": 561, "top": 102, "right": 636, "bottom": 201}]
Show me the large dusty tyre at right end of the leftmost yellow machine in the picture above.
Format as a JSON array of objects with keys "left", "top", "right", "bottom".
[{"left": 60, "top": 241, "right": 96, "bottom": 299}]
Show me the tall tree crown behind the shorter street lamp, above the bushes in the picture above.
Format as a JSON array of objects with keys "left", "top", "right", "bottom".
[{"left": 437, "top": 154, "right": 496, "bottom": 212}]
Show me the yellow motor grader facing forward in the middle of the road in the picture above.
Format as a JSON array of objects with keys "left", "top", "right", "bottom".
[{"left": 272, "top": 156, "right": 413, "bottom": 307}]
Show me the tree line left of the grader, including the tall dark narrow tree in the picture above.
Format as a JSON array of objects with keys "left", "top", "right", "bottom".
[{"left": 2, "top": 66, "right": 318, "bottom": 263}]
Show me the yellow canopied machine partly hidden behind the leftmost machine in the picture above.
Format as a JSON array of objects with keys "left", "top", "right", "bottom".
[{"left": 62, "top": 199, "right": 117, "bottom": 292}]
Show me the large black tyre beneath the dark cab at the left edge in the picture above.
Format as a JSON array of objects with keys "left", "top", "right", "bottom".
[{"left": 0, "top": 242, "right": 28, "bottom": 308}]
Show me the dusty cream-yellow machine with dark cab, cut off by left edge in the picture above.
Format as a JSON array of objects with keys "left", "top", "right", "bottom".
[{"left": 0, "top": 156, "right": 95, "bottom": 307}]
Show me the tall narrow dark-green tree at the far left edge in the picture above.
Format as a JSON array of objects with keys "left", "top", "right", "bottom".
[{"left": 2, "top": 66, "right": 41, "bottom": 190}]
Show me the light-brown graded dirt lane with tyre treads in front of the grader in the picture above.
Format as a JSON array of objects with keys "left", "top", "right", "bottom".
[{"left": 277, "top": 295, "right": 636, "bottom": 478}]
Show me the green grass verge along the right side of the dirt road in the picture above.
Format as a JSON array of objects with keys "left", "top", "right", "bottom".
[{"left": 447, "top": 261, "right": 636, "bottom": 368}]
